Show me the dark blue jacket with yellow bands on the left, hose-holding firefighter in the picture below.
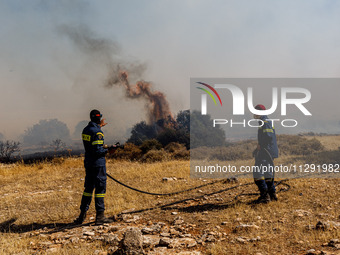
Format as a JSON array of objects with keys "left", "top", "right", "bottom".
[{"left": 82, "top": 121, "right": 108, "bottom": 167}]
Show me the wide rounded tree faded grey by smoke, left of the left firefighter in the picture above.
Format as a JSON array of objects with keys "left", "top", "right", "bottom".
[{"left": 23, "top": 119, "right": 70, "bottom": 145}]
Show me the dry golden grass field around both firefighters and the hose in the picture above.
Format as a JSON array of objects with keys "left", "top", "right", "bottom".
[{"left": 0, "top": 136, "right": 340, "bottom": 255}]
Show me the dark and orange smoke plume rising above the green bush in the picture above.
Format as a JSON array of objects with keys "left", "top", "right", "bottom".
[{"left": 59, "top": 26, "right": 172, "bottom": 124}]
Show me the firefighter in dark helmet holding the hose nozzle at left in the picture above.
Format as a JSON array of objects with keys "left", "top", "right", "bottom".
[{"left": 74, "top": 110, "right": 112, "bottom": 224}]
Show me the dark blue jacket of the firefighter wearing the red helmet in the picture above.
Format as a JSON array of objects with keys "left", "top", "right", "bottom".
[{"left": 257, "top": 115, "right": 279, "bottom": 158}]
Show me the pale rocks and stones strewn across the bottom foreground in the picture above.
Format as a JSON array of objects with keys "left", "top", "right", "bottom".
[{"left": 10, "top": 201, "right": 340, "bottom": 255}]
